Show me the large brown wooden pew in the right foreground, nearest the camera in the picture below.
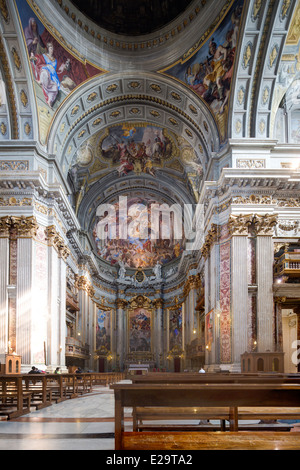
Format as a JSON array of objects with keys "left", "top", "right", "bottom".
[{"left": 111, "top": 383, "right": 300, "bottom": 450}]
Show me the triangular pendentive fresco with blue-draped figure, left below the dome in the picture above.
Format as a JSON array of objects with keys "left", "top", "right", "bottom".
[{"left": 16, "top": 0, "right": 104, "bottom": 144}]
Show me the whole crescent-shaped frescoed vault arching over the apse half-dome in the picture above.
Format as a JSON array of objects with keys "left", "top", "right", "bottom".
[{"left": 65, "top": 123, "right": 203, "bottom": 213}]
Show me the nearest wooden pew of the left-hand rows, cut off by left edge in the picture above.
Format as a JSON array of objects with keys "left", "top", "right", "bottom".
[{"left": 0, "top": 375, "right": 32, "bottom": 419}]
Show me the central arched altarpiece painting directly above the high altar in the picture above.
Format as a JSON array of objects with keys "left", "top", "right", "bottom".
[{"left": 129, "top": 308, "right": 151, "bottom": 352}]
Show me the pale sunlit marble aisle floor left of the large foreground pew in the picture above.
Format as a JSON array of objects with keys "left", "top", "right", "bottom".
[{"left": 0, "top": 386, "right": 298, "bottom": 451}]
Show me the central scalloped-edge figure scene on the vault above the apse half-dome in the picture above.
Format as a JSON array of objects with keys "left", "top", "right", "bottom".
[{"left": 101, "top": 123, "right": 173, "bottom": 176}]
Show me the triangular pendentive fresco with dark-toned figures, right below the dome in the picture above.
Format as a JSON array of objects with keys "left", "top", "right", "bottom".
[{"left": 161, "top": 0, "right": 244, "bottom": 141}]
